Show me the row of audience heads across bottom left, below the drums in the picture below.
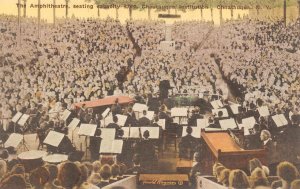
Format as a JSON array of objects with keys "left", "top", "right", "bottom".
[{"left": 0, "top": 160, "right": 127, "bottom": 189}]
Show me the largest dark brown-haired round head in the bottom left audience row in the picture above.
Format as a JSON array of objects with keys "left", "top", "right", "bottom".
[{"left": 57, "top": 162, "right": 81, "bottom": 189}]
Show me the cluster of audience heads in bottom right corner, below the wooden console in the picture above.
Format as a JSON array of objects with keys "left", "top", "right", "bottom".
[{"left": 209, "top": 158, "right": 300, "bottom": 189}]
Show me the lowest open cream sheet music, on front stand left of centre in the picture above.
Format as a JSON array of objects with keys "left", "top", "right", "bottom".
[{"left": 99, "top": 140, "right": 123, "bottom": 154}]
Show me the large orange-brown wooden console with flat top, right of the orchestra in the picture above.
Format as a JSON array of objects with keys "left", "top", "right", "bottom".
[{"left": 201, "top": 130, "right": 268, "bottom": 174}]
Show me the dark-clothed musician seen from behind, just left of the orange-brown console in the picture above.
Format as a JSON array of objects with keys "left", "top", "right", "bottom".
[{"left": 179, "top": 126, "right": 197, "bottom": 159}]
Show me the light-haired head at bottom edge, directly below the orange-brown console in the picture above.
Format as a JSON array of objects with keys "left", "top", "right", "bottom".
[{"left": 229, "top": 169, "right": 250, "bottom": 189}]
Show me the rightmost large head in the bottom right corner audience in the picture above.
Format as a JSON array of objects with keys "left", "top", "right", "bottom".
[{"left": 272, "top": 161, "right": 299, "bottom": 189}]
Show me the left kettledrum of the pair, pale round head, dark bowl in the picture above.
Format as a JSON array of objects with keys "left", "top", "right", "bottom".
[{"left": 18, "top": 150, "right": 47, "bottom": 172}]
